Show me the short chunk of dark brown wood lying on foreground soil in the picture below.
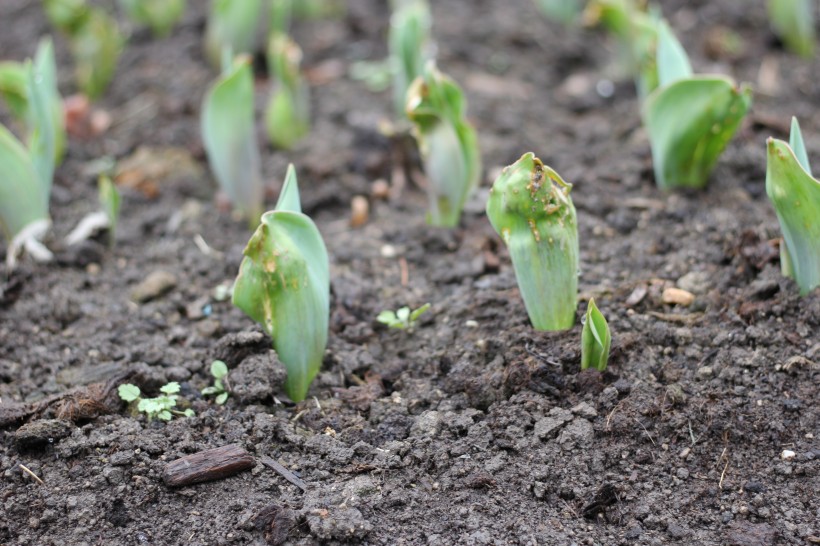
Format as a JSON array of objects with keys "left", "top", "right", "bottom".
[{"left": 162, "top": 444, "right": 256, "bottom": 487}]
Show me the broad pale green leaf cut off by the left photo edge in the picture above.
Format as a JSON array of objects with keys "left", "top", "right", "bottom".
[{"left": 0, "top": 125, "right": 48, "bottom": 239}]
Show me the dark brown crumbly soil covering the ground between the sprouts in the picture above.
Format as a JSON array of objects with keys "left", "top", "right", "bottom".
[{"left": 0, "top": 0, "right": 820, "bottom": 545}]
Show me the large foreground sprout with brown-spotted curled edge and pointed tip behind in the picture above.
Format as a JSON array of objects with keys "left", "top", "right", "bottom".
[{"left": 233, "top": 165, "right": 330, "bottom": 402}]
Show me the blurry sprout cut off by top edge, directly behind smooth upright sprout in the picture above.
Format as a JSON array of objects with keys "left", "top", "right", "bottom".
[{"left": 205, "top": 0, "right": 262, "bottom": 67}]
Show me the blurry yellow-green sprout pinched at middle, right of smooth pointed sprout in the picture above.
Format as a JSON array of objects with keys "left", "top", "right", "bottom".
[{"left": 265, "top": 33, "right": 310, "bottom": 149}]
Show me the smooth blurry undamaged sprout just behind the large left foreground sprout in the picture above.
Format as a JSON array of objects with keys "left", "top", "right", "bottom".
[{"left": 202, "top": 55, "right": 264, "bottom": 225}]
